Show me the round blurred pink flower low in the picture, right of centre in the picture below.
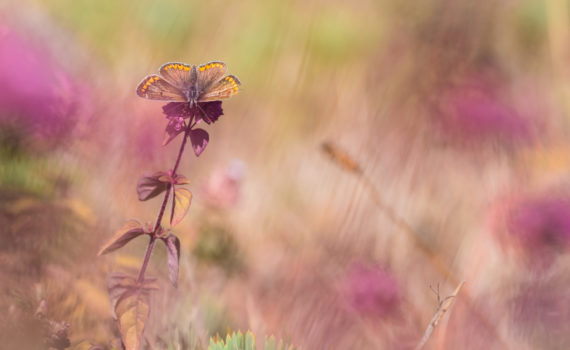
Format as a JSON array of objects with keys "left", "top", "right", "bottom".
[{"left": 343, "top": 263, "right": 400, "bottom": 317}]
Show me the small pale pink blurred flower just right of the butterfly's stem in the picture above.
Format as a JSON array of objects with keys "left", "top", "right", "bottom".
[{"left": 202, "top": 160, "right": 245, "bottom": 209}]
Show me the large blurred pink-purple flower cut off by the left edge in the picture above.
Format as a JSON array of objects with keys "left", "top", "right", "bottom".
[{"left": 0, "top": 25, "right": 83, "bottom": 146}]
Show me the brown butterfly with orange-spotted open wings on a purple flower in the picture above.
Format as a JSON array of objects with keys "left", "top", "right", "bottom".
[{"left": 137, "top": 61, "right": 241, "bottom": 107}]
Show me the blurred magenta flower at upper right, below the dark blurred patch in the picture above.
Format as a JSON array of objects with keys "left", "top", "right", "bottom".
[{"left": 438, "top": 76, "right": 533, "bottom": 145}]
